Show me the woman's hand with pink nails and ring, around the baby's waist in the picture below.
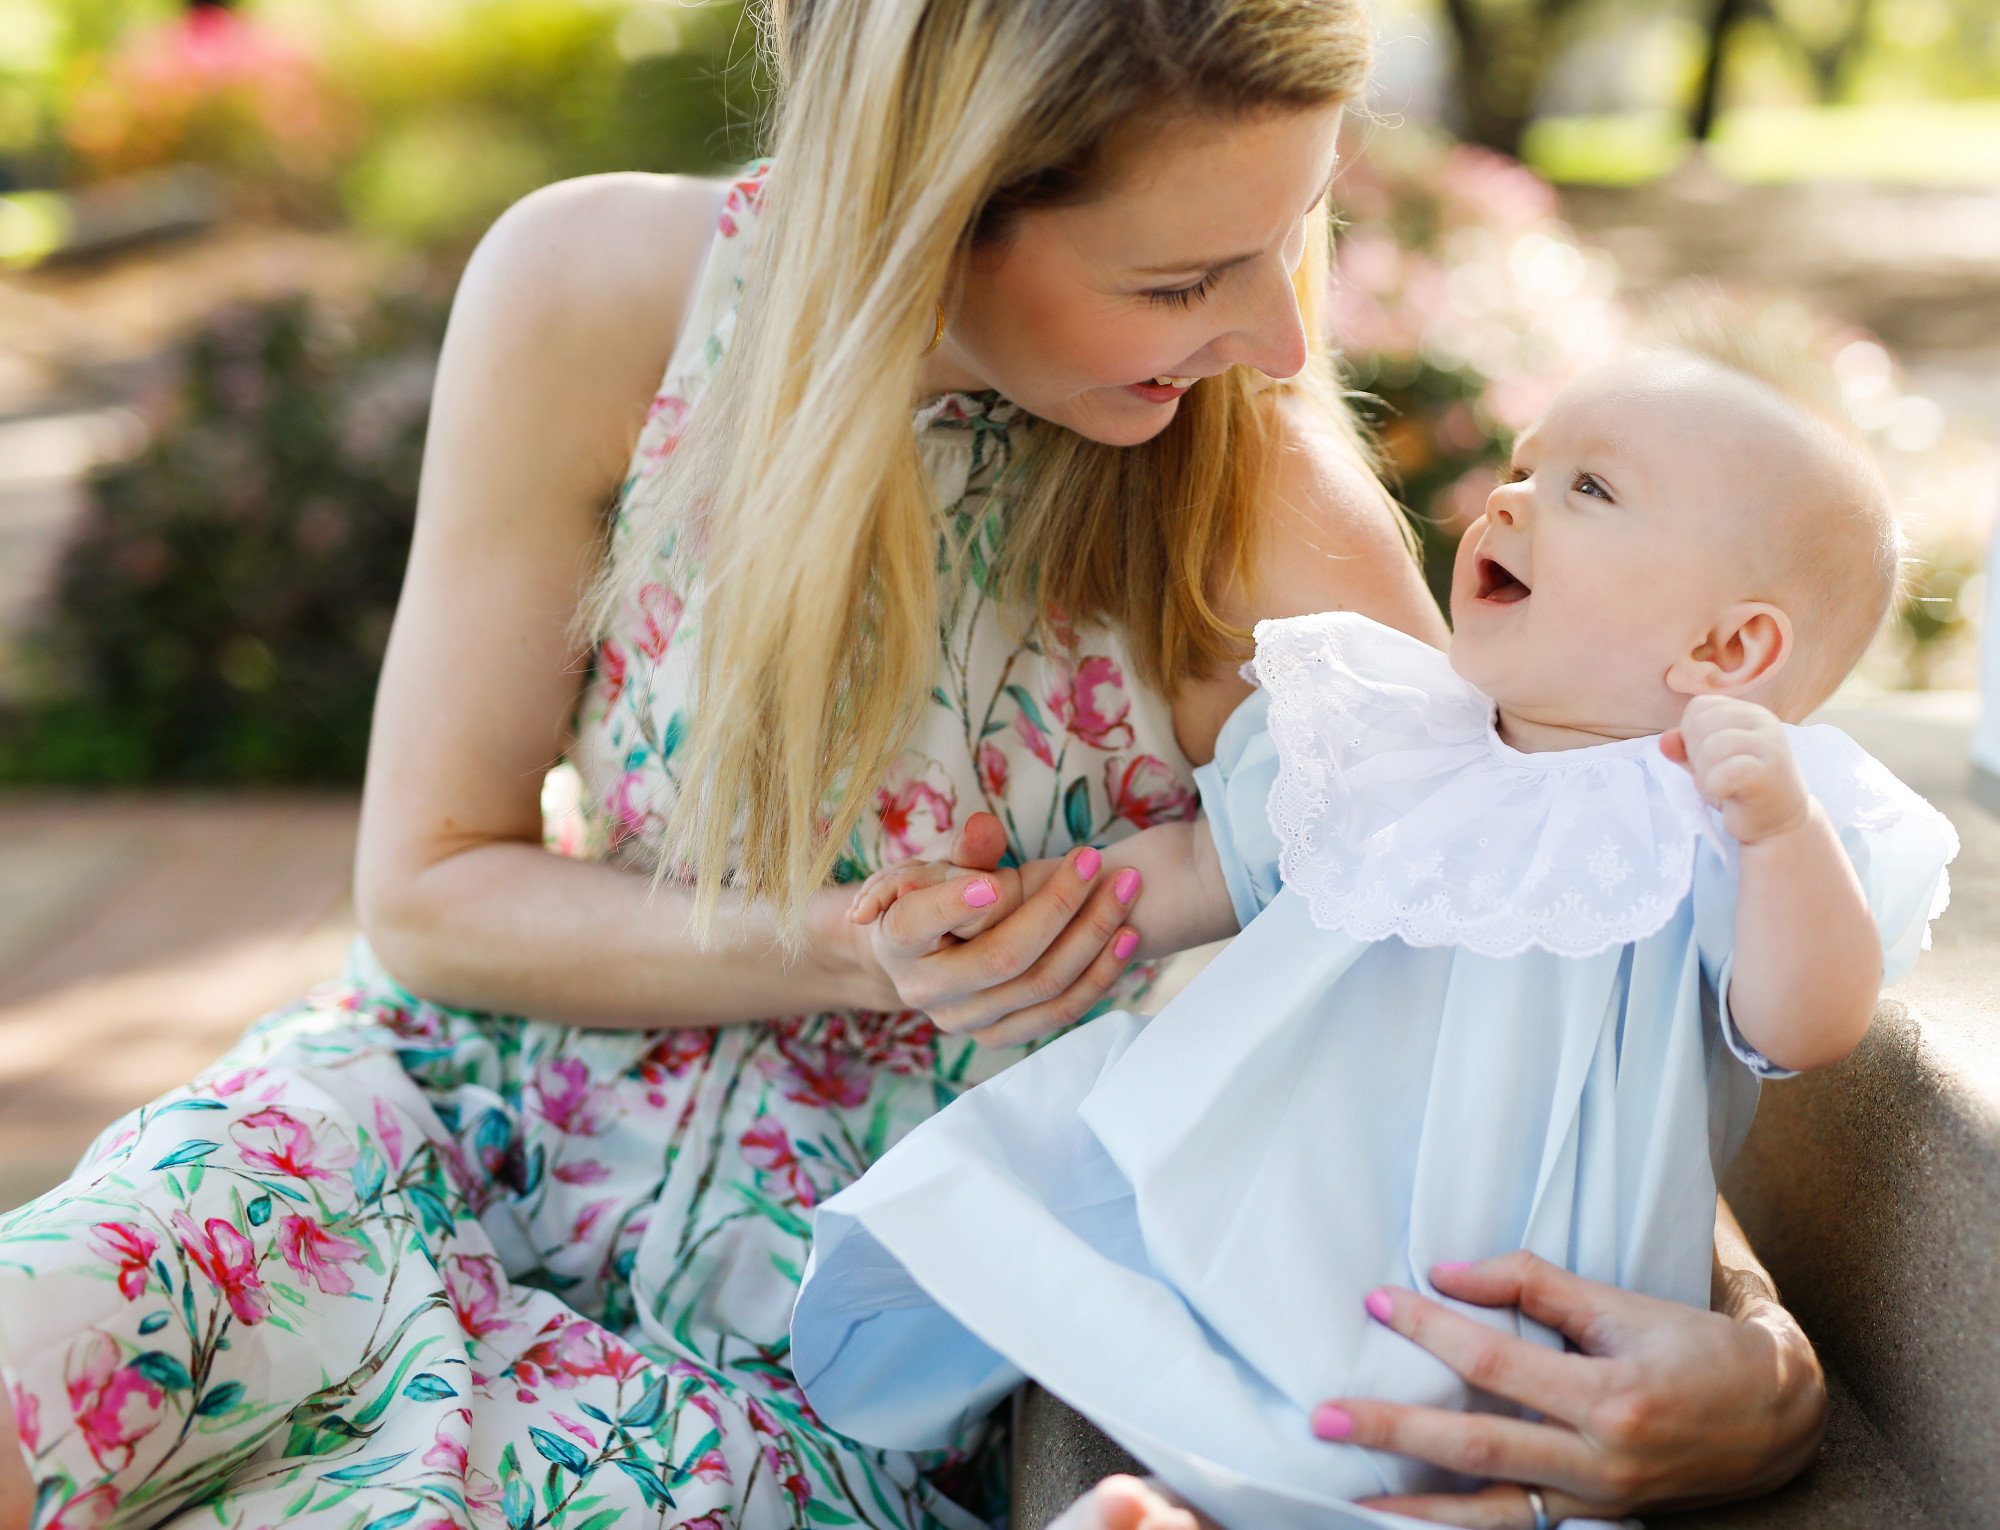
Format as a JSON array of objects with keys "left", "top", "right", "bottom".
[{"left": 1314, "top": 1248, "right": 1826, "bottom": 1530}]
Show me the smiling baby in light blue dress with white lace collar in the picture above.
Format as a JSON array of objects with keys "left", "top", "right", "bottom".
[{"left": 792, "top": 328, "right": 1956, "bottom": 1530}]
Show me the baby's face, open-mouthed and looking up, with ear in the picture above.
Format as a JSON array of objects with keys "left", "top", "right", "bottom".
[{"left": 1452, "top": 356, "right": 1796, "bottom": 736}]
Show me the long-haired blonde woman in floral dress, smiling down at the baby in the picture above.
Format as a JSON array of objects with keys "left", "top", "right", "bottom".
[{"left": 0, "top": 0, "right": 1820, "bottom": 1530}]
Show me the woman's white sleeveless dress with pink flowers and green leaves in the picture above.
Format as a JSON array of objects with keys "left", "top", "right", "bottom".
[{"left": 0, "top": 161, "right": 1196, "bottom": 1530}]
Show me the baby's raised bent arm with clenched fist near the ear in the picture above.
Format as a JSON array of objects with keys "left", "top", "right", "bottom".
[{"left": 1660, "top": 696, "right": 1882, "bottom": 1070}]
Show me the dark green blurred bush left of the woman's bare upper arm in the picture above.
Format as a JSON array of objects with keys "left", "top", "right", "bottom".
[{"left": 0, "top": 298, "right": 444, "bottom": 784}]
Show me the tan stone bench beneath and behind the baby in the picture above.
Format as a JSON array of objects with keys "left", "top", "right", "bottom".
[{"left": 1014, "top": 696, "right": 2000, "bottom": 1530}]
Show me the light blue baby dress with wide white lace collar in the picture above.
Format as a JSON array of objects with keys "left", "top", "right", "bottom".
[{"left": 792, "top": 614, "right": 1958, "bottom": 1530}]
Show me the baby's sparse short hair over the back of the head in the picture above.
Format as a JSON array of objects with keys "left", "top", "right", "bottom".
[{"left": 1644, "top": 290, "right": 1904, "bottom": 718}]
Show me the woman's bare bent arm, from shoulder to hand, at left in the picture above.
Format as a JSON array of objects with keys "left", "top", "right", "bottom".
[{"left": 356, "top": 176, "right": 1124, "bottom": 1026}]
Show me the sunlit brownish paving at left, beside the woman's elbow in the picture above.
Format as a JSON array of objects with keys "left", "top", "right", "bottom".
[{"left": 0, "top": 796, "right": 356, "bottom": 1208}]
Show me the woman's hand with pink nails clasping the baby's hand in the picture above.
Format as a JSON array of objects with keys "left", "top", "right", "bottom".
[{"left": 858, "top": 812, "right": 1138, "bottom": 1046}]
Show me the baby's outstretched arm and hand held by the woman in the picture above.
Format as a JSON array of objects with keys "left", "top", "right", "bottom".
[{"left": 848, "top": 816, "right": 1238, "bottom": 958}]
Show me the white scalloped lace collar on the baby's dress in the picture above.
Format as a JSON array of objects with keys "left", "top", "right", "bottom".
[{"left": 1252, "top": 612, "right": 1824, "bottom": 956}]
